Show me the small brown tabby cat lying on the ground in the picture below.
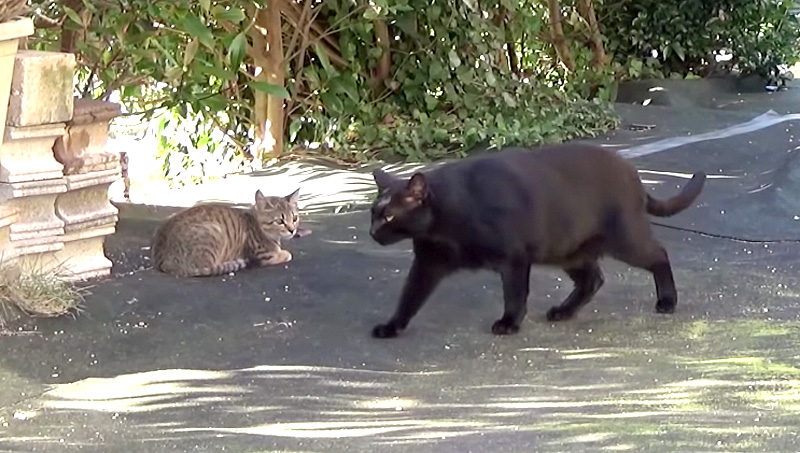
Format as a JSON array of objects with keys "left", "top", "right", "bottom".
[{"left": 151, "top": 189, "right": 300, "bottom": 277}]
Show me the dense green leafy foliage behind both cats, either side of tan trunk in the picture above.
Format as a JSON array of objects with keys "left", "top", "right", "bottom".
[{"left": 32, "top": 0, "right": 616, "bottom": 184}]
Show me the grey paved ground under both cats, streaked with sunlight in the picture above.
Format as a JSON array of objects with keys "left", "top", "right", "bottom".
[{"left": 0, "top": 79, "right": 800, "bottom": 453}]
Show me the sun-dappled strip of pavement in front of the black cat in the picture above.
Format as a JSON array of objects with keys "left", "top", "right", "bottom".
[{"left": 0, "top": 321, "right": 800, "bottom": 451}]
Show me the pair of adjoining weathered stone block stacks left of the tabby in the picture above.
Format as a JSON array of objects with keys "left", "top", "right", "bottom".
[{"left": 0, "top": 51, "right": 120, "bottom": 280}]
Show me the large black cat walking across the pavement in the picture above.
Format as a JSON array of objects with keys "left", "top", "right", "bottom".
[{"left": 370, "top": 143, "right": 706, "bottom": 338}]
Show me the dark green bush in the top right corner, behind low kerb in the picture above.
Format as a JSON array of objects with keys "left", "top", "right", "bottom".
[{"left": 598, "top": 0, "right": 800, "bottom": 78}]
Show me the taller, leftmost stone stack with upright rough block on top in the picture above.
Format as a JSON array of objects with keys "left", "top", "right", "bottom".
[{"left": 0, "top": 51, "right": 75, "bottom": 269}]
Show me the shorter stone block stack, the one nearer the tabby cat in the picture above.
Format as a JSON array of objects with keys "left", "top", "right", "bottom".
[{"left": 53, "top": 99, "right": 121, "bottom": 279}]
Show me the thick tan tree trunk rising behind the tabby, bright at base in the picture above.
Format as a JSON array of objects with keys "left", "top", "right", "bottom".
[{"left": 253, "top": 0, "right": 286, "bottom": 162}]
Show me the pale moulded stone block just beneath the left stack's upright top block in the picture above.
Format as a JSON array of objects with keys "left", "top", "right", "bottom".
[{"left": 0, "top": 123, "right": 65, "bottom": 183}]
